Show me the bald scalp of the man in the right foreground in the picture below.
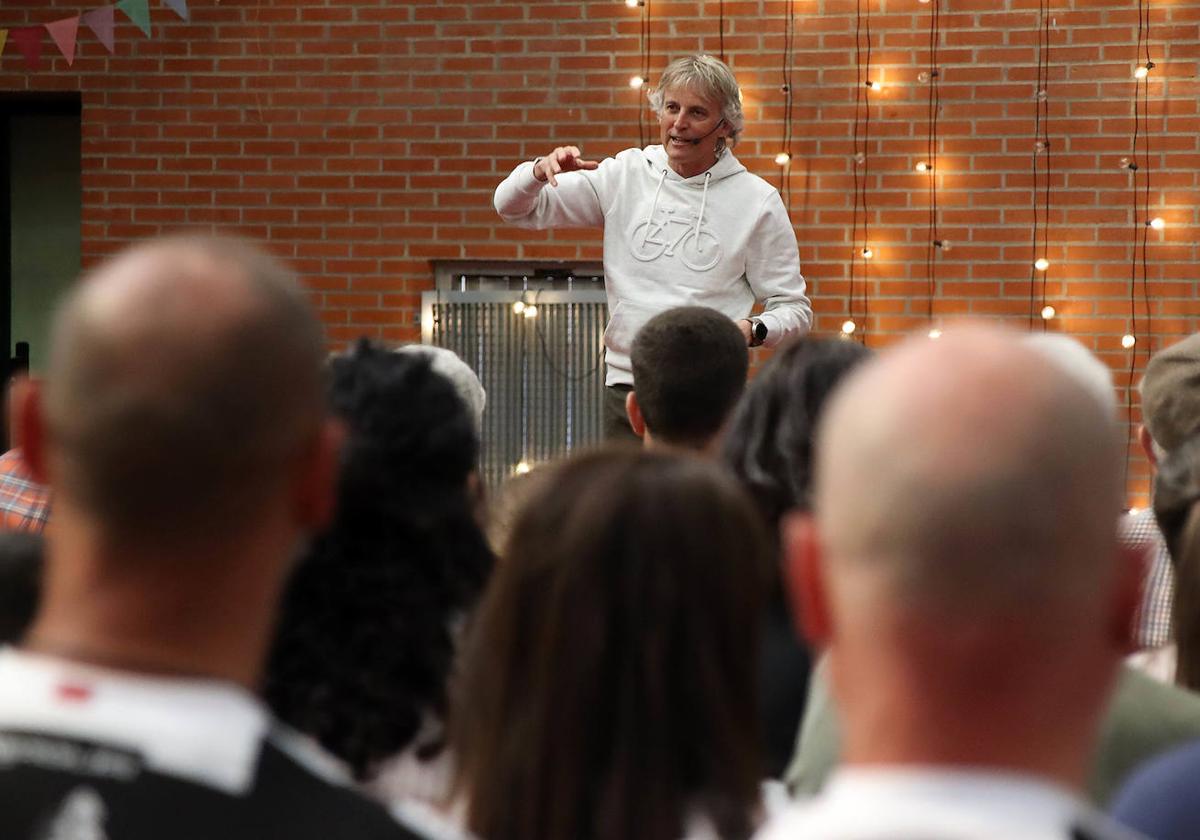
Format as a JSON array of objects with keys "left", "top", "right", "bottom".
[{"left": 816, "top": 328, "right": 1121, "bottom": 616}]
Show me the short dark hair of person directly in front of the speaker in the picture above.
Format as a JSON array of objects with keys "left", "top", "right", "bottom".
[{"left": 630, "top": 306, "right": 750, "bottom": 446}]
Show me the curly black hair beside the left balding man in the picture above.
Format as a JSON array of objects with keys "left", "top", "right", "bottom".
[{"left": 264, "top": 340, "right": 493, "bottom": 781}]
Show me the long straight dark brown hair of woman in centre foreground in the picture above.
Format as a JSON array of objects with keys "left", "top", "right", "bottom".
[{"left": 452, "top": 450, "right": 768, "bottom": 840}]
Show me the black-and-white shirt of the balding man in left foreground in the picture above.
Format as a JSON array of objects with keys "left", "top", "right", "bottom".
[{"left": 0, "top": 650, "right": 427, "bottom": 840}]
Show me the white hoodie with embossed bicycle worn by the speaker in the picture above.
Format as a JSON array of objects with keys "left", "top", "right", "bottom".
[{"left": 496, "top": 146, "right": 812, "bottom": 385}]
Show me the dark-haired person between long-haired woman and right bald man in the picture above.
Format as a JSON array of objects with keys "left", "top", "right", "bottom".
[{"left": 722, "top": 338, "right": 871, "bottom": 778}]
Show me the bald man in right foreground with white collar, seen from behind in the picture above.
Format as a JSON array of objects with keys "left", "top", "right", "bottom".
[{"left": 766, "top": 328, "right": 1138, "bottom": 838}]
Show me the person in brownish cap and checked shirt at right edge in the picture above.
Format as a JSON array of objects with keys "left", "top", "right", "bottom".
[{"left": 1124, "top": 335, "right": 1200, "bottom": 649}]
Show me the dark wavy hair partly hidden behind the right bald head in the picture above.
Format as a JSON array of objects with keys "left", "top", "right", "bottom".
[{"left": 722, "top": 338, "right": 871, "bottom": 534}]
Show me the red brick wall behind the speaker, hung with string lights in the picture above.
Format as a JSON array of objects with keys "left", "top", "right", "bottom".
[{"left": 0, "top": 0, "right": 1200, "bottom": 499}]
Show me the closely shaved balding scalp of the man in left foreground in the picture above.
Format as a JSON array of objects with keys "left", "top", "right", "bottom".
[{"left": 44, "top": 232, "right": 324, "bottom": 542}]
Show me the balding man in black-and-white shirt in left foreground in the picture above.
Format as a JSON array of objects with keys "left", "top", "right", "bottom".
[{"left": 0, "top": 238, "right": 427, "bottom": 840}]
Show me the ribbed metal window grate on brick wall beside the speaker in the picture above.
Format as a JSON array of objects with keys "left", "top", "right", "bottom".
[{"left": 421, "top": 286, "right": 608, "bottom": 487}]
